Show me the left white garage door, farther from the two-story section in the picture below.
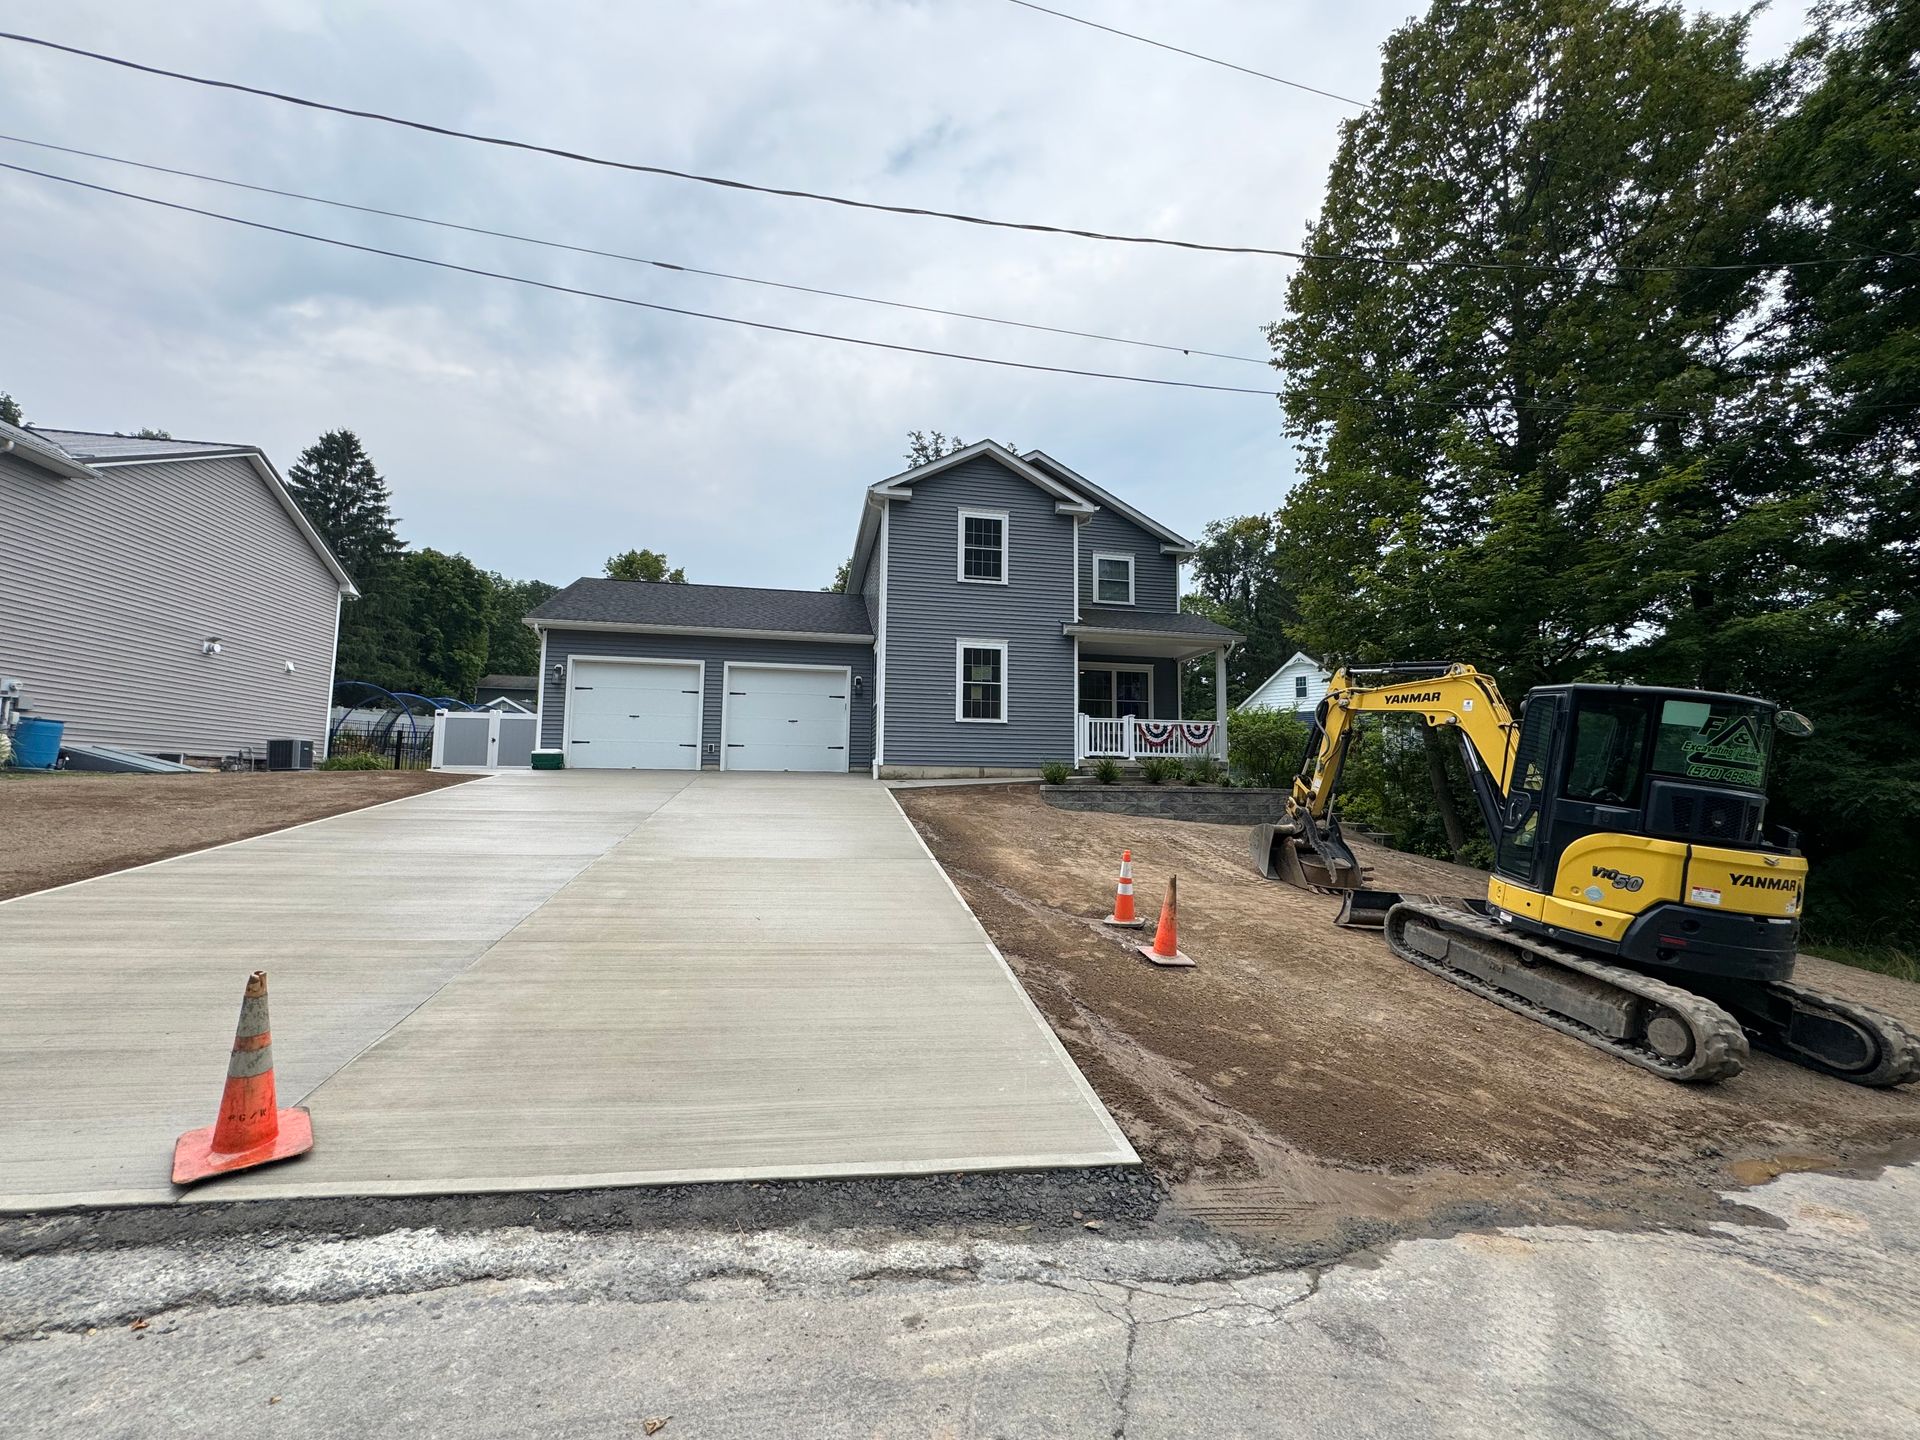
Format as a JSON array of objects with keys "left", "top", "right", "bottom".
[{"left": 566, "top": 657, "right": 701, "bottom": 770}]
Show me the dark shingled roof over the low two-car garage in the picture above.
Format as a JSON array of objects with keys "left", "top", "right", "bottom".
[{"left": 526, "top": 580, "right": 874, "bottom": 641}]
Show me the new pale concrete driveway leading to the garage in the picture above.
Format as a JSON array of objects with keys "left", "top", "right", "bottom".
[{"left": 0, "top": 772, "right": 1135, "bottom": 1212}]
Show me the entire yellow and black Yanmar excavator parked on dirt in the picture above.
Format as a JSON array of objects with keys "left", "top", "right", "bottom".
[{"left": 1252, "top": 662, "right": 1920, "bottom": 1087}]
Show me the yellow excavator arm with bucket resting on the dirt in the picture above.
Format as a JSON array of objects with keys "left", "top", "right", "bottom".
[{"left": 1252, "top": 662, "right": 1519, "bottom": 891}]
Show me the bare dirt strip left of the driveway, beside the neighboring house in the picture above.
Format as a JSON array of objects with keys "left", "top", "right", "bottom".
[{"left": 0, "top": 770, "right": 470, "bottom": 900}]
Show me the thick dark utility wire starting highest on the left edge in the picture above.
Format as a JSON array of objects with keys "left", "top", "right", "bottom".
[{"left": 0, "top": 31, "right": 1896, "bottom": 276}]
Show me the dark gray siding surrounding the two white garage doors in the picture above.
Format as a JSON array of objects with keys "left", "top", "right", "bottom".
[{"left": 540, "top": 630, "right": 874, "bottom": 770}]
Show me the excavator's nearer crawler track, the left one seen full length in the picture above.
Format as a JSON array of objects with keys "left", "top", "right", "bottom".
[{"left": 1386, "top": 900, "right": 1758, "bottom": 1085}]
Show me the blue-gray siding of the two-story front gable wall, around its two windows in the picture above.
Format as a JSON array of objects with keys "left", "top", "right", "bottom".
[{"left": 883, "top": 457, "right": 1073, "bottom": 766}]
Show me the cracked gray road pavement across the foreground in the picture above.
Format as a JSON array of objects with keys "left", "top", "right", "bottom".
[{"left": 0, "top": 1167, "right": 1920, "bottom": 1440}]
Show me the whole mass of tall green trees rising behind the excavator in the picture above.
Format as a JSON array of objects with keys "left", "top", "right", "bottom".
[{"left": 1188, "top": 0, "right": 1920, "bottom": 960}]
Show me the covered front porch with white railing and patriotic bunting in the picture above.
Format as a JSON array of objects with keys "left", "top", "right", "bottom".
[{"left": 1066, "top": 609, "right": 1240, "bottom": 766}]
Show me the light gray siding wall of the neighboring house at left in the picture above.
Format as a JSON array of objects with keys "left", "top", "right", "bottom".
[{"left": 0, "top": 455, "right": 340, "bottom": 756}]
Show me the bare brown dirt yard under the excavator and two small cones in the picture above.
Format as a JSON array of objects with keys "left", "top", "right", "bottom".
[{"left": 899, "top": 785, "right": 1920, "bottom": 1236}]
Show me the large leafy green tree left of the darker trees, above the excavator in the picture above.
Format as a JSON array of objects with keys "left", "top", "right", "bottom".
[{"left": 1271, "top": 0, "right": 1781, "bottom": 684}]
